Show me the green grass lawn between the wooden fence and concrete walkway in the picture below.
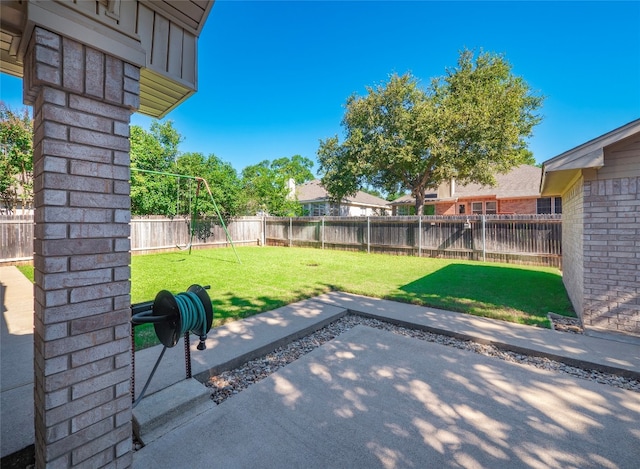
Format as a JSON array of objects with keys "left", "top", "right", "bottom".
[{"left": 18, "top": 247, "right": 575, "bottom": 346}]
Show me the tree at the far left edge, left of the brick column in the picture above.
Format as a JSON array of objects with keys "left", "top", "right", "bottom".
[{"left": 0, "top": 101, "right": 33, "bottom": 210}]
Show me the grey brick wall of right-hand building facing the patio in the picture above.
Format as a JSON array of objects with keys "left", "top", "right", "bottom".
[{"left": 584, "top": 177, "right": 640, "bottom": 335}]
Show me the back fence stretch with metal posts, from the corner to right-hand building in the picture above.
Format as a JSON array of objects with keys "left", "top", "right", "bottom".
[{"left": 265, "top": 215, "right": 562, "bottom": 267}]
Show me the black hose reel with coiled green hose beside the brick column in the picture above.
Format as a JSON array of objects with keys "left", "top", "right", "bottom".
[{"left": 131, "top": 285, "right": 213, "bottom": 407}]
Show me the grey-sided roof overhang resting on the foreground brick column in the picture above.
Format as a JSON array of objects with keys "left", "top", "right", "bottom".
[{"left": 0, "top": 0, "right": 215, "bottom": 118}]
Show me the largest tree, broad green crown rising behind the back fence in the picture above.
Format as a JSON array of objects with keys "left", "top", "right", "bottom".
[{"left": 318, "top": 50, "right": 543, "bottom": 213}]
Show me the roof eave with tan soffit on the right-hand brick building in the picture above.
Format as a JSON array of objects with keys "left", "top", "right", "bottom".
[{"left": 540, "top": 119, "right": 640, "bottom": 196}]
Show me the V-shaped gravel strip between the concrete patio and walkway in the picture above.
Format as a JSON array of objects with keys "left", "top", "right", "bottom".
[{"left": 206, "top": 314, "right": 640, "bottom": 404}]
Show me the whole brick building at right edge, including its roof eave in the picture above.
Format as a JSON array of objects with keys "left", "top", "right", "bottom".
[{"left": 540, "top": 119, "right": 640, "bottom": 335}]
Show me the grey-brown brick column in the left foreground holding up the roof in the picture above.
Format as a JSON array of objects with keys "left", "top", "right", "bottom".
[{"left": 24, "top": 27, "right": 140, "bottom": 468}]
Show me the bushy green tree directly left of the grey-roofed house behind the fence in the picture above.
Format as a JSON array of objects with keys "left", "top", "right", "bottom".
[{"left": 242, "top": 155, "right": 314, "bottom": 216}]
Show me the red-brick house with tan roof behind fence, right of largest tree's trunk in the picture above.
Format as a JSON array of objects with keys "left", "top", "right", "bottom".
[{"left": 391, "top": 165, "right": 562, "bottom": 215}]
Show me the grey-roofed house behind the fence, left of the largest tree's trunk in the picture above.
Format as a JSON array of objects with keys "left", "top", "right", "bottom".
[{"left": 295, "top": 179, "right": 389, "bottom": 217}]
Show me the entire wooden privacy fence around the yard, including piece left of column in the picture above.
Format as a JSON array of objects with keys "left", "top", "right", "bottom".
[{"left": 0, "top": 215, "right": 562, "bottom": 267}]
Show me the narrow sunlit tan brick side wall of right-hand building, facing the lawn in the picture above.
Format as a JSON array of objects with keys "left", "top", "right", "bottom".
[{"left": 562, "top": 178, "right": 584, "bottom": 319}]
